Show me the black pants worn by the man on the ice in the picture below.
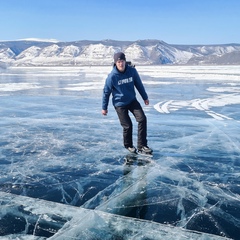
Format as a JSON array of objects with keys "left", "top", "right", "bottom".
[{"left": 115, "top": 100, "right": 147, "bottom": 149}]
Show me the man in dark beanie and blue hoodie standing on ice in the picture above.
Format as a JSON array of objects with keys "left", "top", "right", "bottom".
[{"left": 102, "top": 52, "right": 152, "bottom": 154}]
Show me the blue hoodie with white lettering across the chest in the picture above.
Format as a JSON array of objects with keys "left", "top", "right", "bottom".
[{"left": 102, "top": 65, "right": 148, "bottom": 110}]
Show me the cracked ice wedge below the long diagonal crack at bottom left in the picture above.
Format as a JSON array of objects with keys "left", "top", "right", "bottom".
[{"left": 1, "top": 192, "right": 229, "bottom": 240}]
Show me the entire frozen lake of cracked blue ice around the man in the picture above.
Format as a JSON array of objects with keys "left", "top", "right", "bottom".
[{"left": 0, "top": 66, "right": 240, "bottom": 240}]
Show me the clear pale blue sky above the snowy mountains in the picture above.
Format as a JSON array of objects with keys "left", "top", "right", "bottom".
[{"left": 0, "top": 0, "right": 240, "bottom": 44}]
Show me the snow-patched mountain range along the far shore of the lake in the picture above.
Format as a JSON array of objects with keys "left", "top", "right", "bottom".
[{"left": 0, "top": 39, "right": 240, "bottom": 66}]
